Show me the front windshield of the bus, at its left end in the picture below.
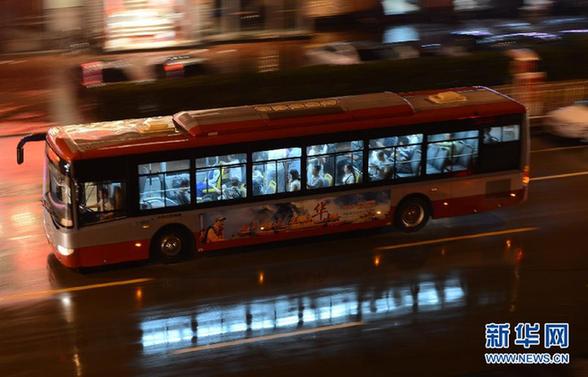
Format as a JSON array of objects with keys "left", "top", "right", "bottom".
[{"left": 43, "top": 159, "right": 73, "bottom": 227}]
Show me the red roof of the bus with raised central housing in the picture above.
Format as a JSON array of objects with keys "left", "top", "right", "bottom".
[{"left": 47, "top": 87, "right": 525, "bottom": 162}]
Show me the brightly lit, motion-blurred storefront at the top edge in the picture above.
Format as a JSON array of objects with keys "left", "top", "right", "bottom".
[{"left": 83, "top": 0, "right": 311, "bottom": 50}]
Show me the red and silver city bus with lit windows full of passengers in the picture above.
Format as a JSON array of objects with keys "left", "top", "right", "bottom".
[{"left": 17, "top": 87, "right": 529, "bottom": 268}]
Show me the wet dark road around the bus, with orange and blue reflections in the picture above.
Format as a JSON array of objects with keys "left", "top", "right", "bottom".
[{"left": 0, "top": 135, "right": 588, "bottom": 376}]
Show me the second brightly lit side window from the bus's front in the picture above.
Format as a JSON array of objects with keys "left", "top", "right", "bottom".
[{"left": 196, "top": 153, "right": 247, "bottom": 203}]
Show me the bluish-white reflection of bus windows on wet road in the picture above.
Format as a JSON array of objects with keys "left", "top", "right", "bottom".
[{"left": 141, "top": 279, "right": 464, "bottom": 353}]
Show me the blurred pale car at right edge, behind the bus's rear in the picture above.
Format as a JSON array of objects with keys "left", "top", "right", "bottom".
[{"left": 544, "top": 99, "right": 588, "bottom": 142}]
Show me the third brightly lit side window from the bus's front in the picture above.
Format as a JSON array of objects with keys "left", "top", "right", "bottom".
[{"left": 252, "top": 148, "right": 302, "bottom": 196}]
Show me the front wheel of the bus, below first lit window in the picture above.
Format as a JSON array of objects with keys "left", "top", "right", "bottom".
[{"left": 151, "top": 225, "right": 194, "bottom": 263}]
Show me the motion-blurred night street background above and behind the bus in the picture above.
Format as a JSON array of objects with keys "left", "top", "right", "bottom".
[{"left": 0, "top": 0, "right": 588, "bottom": 135}]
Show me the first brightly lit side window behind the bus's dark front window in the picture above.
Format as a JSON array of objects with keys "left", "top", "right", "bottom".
[{"left": 138, "top": 160, "right": 191, "bottom": 210}]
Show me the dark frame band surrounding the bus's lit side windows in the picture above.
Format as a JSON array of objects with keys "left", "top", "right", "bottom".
[{"left": 112, "top": 113, "right": 528, "bottom": 217}]
